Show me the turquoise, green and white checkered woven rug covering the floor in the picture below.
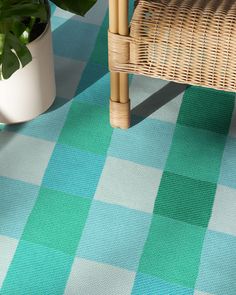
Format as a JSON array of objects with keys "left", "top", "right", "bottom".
[{"left": 0, "top": 0, "right": 236, "bottom": 295}]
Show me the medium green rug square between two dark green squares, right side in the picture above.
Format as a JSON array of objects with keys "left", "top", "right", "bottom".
[{"left": 165, "top": 124, "right": 226, "bottom": 183}]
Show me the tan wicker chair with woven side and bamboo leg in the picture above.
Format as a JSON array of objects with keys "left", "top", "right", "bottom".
[{"left": 108, "top": 0, "right": 236, "bottom": 128}]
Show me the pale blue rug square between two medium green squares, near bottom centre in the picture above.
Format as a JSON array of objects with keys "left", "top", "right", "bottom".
[{"left": 77, "top": 201, "right": 151, "bottom": 271}]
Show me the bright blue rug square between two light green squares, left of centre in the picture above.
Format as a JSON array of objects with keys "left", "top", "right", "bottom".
[{"left": 43, "top": 144, "right": 105, "bottom": 198}]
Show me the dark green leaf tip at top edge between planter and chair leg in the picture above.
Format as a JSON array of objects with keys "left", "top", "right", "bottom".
[{"left": 51, "top": 0, "right": 97, "bottom": 16}]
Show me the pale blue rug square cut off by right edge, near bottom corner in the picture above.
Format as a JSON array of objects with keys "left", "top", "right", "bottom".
[{"left": 196, "top": 231, "right": 236, "bottom": 295}]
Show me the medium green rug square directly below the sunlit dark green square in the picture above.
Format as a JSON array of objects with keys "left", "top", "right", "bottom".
[{"left": 139, "top": 215, "right": 205, "bottom": 288}]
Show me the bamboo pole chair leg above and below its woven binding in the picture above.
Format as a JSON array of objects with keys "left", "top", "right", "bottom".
[{"left": 109, "top": 0, "right": 130, "bottom": 129}]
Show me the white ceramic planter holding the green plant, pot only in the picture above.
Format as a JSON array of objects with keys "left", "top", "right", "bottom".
[{"left": 0, "top": 24, "right": 56, "bottom": 124}]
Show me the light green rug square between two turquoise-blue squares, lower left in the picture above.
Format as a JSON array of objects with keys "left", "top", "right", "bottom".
[{"left": 22, "top": 188, "right": 91, "bottom": 255}]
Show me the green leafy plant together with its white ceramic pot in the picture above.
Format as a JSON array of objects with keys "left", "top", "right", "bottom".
[{"left": 0, "top": 0, "right": 97, "bottom": 124}]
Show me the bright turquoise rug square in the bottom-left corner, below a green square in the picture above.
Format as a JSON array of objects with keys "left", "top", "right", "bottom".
[{"left": 0, "top": 240, "right": 74, "bottom": 295}]
